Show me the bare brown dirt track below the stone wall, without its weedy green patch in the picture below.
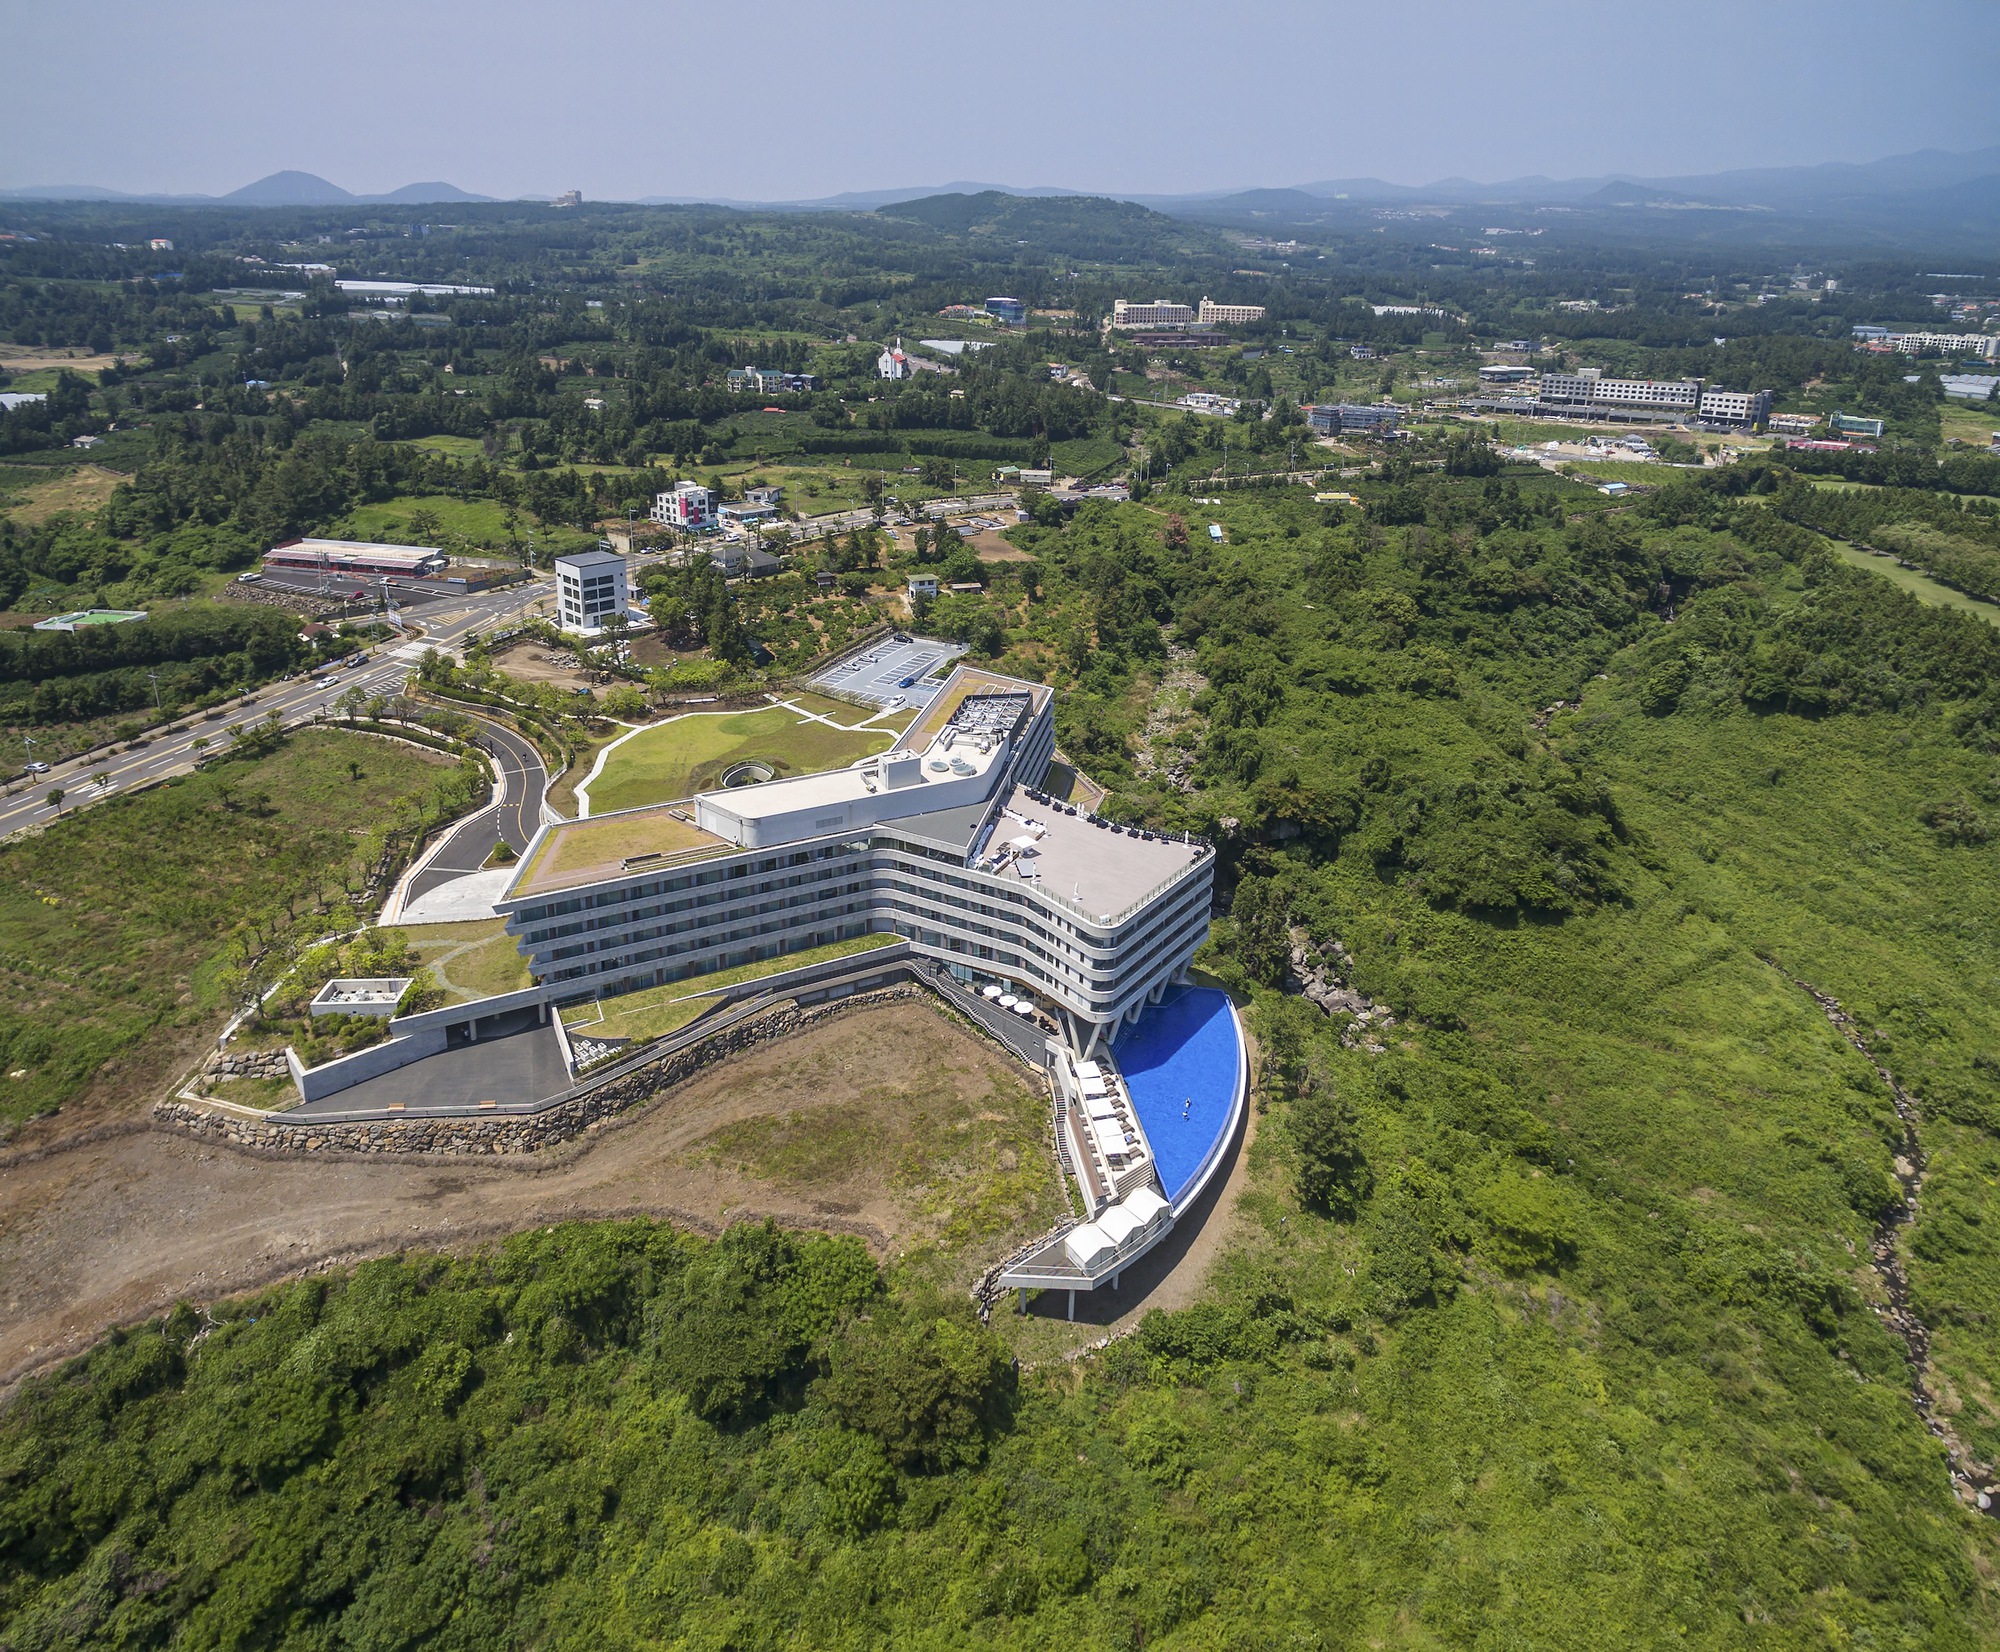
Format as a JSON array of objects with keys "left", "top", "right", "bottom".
[{"left": 0, "top": 1004, "right": 1022, "bottom": 1388}]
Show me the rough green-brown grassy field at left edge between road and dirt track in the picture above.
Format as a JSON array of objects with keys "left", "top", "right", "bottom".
[{"left": 0, "top": 732, "right": 460, "bottom": 1124}]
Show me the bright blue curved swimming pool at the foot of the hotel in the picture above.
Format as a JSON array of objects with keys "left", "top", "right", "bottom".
[{"left": 1112, "top": 986, "right": 1242, "bottom": 1210}]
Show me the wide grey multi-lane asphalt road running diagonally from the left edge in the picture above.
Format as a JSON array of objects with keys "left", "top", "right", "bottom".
[{"left": 0, "top": 582, "right": 552, "bottom": 848}]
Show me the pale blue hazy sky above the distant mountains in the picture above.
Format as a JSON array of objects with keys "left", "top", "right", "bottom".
[{"left": 0, "top": 0, "right": 2000, "bottom": 200}]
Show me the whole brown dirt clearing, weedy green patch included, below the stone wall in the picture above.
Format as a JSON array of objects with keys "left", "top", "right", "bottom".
[{"left": 0, "top": 1002, "right": 1056, "bottom": 1390}]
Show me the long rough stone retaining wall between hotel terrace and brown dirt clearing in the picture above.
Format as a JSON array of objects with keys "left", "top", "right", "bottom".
[{"left": 152, "top": 982, "right": 924, "bottom": 1156}]
